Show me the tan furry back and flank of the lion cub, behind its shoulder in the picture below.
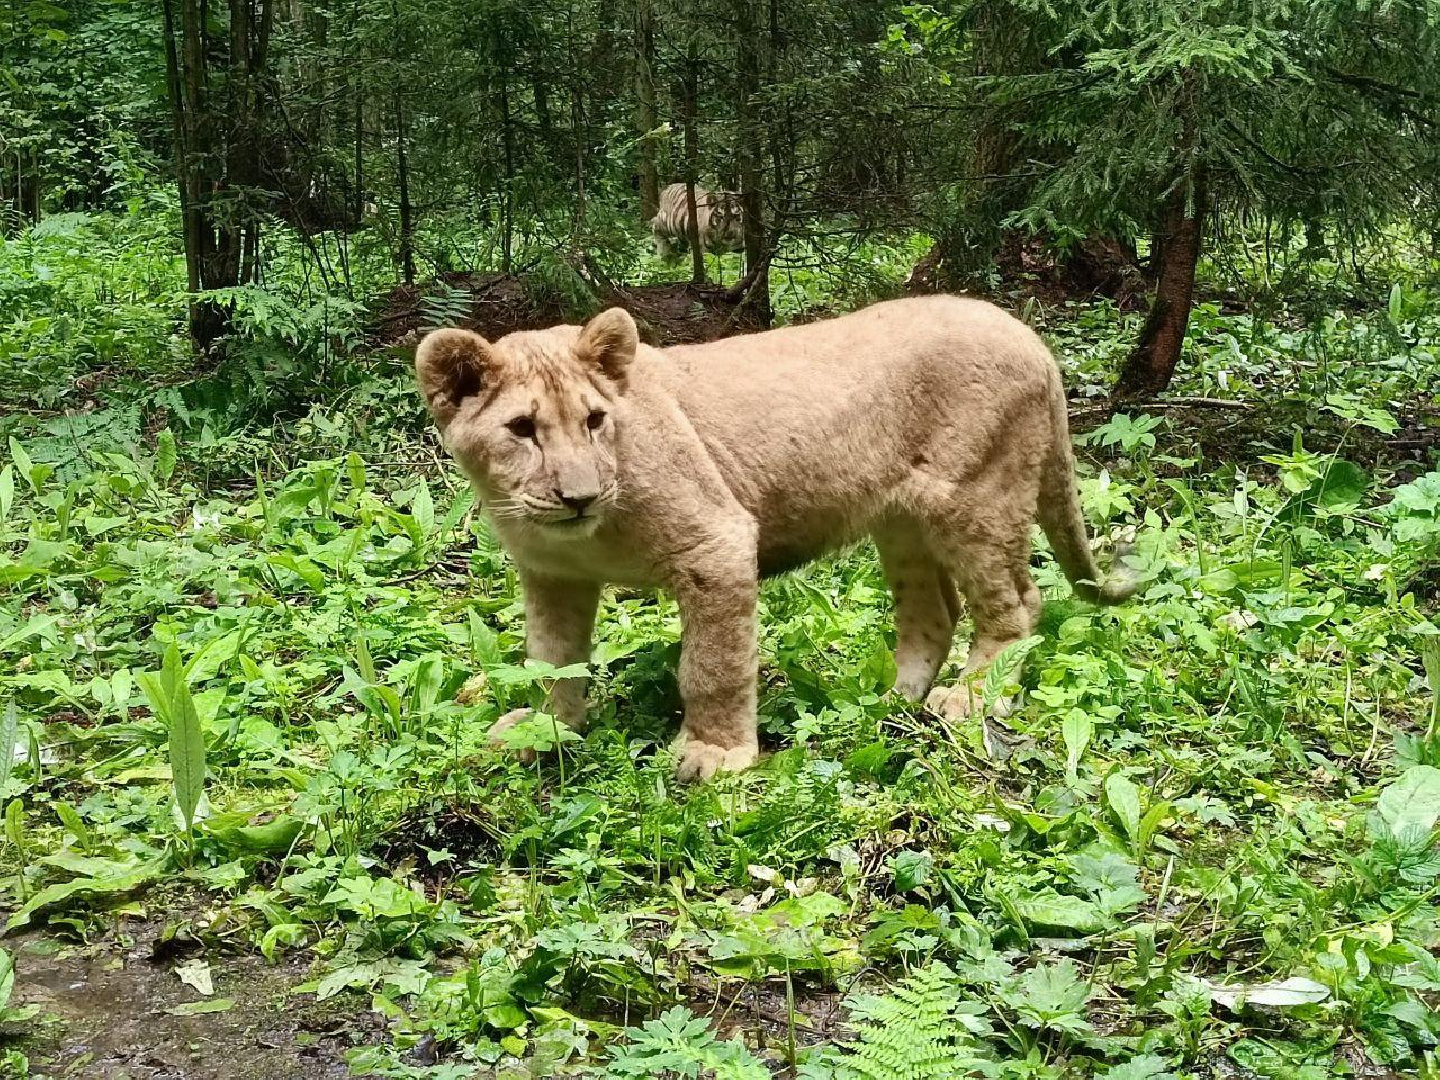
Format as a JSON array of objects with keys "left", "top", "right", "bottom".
[{"left": 653, "top": 297, "right": 1060, "bottom": 541}]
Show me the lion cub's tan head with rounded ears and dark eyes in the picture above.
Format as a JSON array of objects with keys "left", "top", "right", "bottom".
[{"left": 415, "top": 308, "right": 638, "bottom": 536}]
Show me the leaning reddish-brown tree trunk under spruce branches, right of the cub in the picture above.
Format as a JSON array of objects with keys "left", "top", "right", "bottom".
[{"left": 1113, "top": 181, "right": 1205, "bottom": 400}]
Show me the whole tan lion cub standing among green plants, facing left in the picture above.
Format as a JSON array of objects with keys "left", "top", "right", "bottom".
[{"left": 416, "top": 297, "right": 1128, "bottom": 778}]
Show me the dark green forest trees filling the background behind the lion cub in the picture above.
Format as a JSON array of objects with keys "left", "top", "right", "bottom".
[{"left": 8, "top": 0, "right": 1440, "bottom": 393}]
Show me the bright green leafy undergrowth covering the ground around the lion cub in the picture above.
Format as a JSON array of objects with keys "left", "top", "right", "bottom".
[{"left": 0, "top": 207, "right": 1440, "bottom": 1080}]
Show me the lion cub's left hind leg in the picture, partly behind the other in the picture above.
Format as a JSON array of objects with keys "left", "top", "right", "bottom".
[{"left": 876, "top": 526, "right": 960, "bottom": 701}]
